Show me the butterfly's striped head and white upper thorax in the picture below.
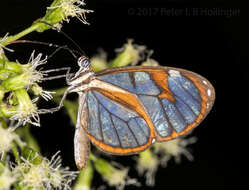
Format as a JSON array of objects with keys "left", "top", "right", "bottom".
[{"left": 67, "top": 56, "right": 94, "bottom": 85}]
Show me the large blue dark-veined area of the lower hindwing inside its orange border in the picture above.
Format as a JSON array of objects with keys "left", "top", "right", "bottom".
[{"left": 88, "top": 91, "right": 149, "bottom": 148}]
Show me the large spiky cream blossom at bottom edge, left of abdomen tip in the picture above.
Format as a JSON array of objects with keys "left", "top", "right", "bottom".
[{"left": 13, "top": 153, "right": 78, "bottom": 190}]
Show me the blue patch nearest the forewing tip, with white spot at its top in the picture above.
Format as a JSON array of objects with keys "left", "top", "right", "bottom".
[{"left": 168, "top": 76, "right": 201, "bottom": 116}]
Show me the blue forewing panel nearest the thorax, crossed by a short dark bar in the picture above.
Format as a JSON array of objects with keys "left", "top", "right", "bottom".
[{"left": 98, "top": 72, "right": 160, "bottom": 95}]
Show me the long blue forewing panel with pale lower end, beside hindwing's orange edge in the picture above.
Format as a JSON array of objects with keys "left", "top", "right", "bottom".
[{"left": 139, "top": 95, "right": 172, "bottom": 137}]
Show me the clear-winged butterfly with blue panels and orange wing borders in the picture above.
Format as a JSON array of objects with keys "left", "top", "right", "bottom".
[{"left": 48, "top": 56, "right": 215, "bottom": 169}]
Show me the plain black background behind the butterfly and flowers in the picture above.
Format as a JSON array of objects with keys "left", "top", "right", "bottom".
[{"left": 0, "top": 0, "right": 249, "bottom": 190}]
